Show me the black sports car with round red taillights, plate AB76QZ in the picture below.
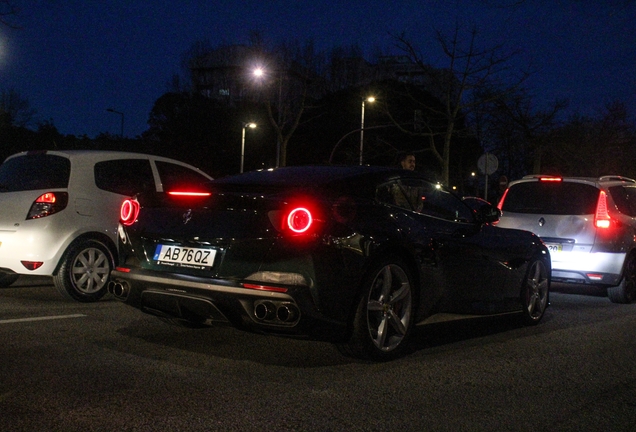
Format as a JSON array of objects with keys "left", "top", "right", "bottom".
[{"left": 109, "top": 166, "right": 550, "bottom": 360}]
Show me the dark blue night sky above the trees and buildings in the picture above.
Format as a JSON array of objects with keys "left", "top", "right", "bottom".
[{"left": 0, "top": 0, "right": 636, "bottom": 138}]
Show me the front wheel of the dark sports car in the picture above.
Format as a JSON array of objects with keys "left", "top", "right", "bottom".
[{"left": 521, "top": 258, "right": 550, "bottom": 325}]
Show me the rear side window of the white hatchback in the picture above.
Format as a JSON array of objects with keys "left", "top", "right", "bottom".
[{"left": 95, "top": 159, "right": 155, "bottom": 195}]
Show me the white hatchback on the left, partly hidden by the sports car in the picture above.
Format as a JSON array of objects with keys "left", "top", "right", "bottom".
[{"left": 0, "top": 150, "right": 211, "bottom": 302}]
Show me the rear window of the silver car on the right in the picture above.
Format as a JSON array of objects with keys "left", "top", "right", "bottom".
[{"left": 501, "top": 181, "right": 598, "bottom": 215}]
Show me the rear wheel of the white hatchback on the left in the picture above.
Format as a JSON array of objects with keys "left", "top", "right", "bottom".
[{"left": 53, "top": 240, "right": 114, "bottom": 303}]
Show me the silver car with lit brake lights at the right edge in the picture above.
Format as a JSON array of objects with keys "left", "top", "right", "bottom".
[{"left": 498, "top": 175, "right": 636, "bottom": 303}]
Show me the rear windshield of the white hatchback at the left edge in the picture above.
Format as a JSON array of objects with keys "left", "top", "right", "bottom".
[{"left": 0, "top": 153, "right": 71, "bottom": 192}]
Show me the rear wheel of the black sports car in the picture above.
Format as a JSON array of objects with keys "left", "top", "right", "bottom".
[{"left": 338, "top": 257, "right": 415, "bottom": 361}]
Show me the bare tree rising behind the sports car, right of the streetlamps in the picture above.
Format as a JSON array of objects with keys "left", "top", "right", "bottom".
[{"left": 395, "top": 25, "right": 527, "bottom": 184}]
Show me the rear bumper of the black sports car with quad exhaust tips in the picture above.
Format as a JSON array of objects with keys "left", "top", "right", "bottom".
[{"left": 109, "top": 269, "right": 347, "bottom": 341}]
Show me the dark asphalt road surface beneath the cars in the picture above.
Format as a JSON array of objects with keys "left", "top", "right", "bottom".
[{"left": 0, "top": 279, "right": 636, "bottom": 432}]
